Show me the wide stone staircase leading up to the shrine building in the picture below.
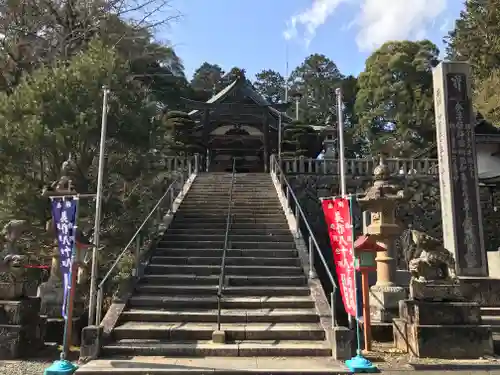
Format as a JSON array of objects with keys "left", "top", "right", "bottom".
[{"left": 79, "top": 173, "right": 344, "bottom": 374}]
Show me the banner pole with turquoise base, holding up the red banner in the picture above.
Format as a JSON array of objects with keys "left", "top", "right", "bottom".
[{"left": 345, "top": 194, "right": 378, "bottom": 373}]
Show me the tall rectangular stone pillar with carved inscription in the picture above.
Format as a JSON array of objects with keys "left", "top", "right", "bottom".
[{"left": 433, "top": 62, "right": 488, "bottom": 276}]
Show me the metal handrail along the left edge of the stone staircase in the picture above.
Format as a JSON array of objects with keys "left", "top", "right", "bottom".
[{"left": 95, "top": 165, "right": 192, "bottom": 325}]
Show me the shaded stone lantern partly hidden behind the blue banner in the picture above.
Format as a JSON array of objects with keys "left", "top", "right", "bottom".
[{"left": 37, "top": 157, "right": 84, "bottom": 345}]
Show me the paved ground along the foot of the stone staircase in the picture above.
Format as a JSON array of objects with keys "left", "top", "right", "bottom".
[{"left": 4, "top": 344, "right": 500, "bottom": 375}]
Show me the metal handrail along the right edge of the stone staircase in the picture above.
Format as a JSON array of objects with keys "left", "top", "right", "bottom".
[{"left": 270, "top": 155, "right": 338, "bottom": 326}]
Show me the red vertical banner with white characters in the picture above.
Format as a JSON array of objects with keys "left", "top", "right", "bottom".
[{"left": 322, "top": 198, "right": 356, "bottom": 316}]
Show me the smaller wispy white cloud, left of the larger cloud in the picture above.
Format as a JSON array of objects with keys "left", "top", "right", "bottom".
[{"left": 283, "top": 0, "right": 346, "bottom": 46}]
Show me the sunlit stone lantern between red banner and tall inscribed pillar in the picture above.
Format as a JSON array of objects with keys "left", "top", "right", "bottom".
[{"left": 358, "top": 156, "right": 406, "bottom": 323}]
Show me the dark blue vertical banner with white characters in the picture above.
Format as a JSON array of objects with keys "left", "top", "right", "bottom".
[{"left": 51, "top": 197, "right": 78, "bottom": 318}]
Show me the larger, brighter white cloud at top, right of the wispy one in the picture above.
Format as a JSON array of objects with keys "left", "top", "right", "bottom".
[{"left": 356, "top": 0, "right": 446, "bottom": 51}]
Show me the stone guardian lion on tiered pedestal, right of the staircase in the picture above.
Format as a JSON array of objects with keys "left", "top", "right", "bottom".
[{"left": 393, "top": 231, "right": 493, "bottom": 358}]
